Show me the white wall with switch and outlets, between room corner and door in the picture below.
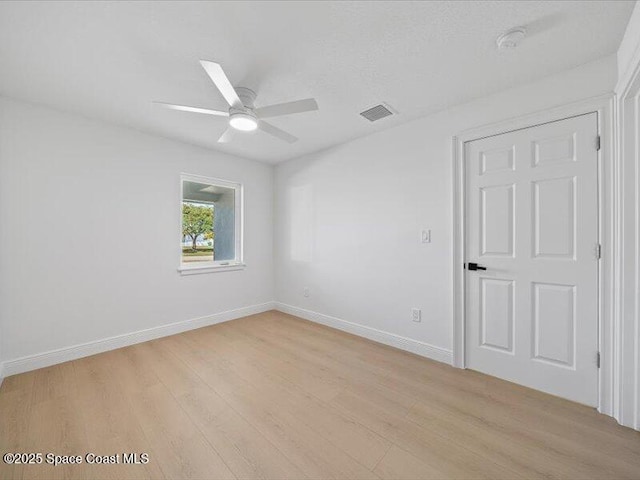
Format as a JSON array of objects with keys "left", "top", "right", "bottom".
[{"left": 275, "top": 56, "right": 616, "bottom": 356}]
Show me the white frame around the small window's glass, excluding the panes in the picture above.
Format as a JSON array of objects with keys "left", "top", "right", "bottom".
[{"left": 178, "top": 173, "right": 246, "bottom": 275}]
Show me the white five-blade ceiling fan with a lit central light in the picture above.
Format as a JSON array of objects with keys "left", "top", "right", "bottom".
[{"left": 153, "top": 60, "right": 318, "bottom": 143}]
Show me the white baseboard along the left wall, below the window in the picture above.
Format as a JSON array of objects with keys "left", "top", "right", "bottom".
[{"left": 0, "top": 302, "right": 275, "bottom": 381}]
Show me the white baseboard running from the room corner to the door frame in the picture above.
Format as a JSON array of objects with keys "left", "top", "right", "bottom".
[{"left": 275, "top": 302, "right": 453, "bottom": 365}]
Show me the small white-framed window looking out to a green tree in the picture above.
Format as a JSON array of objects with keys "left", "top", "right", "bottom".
[{"left": 179, "top": 175, "right": 244, "bottom": 274}]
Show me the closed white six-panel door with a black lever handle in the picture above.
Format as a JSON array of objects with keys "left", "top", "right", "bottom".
[{"left": 465, "top": 113, "right": 598, "bottom": 406}]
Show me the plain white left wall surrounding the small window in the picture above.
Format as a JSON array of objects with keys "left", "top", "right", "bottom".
[{"left": 0, "top": 98, "right": 274, "bottom": 366}]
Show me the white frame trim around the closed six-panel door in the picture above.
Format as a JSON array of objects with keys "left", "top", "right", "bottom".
[{"left": 452, "top": 94, "right": 618, "bottom": 415}]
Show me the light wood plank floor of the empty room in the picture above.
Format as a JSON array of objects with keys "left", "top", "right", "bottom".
[{"left": 0, "top": 312, "right": 640, "bottom": 480}]
